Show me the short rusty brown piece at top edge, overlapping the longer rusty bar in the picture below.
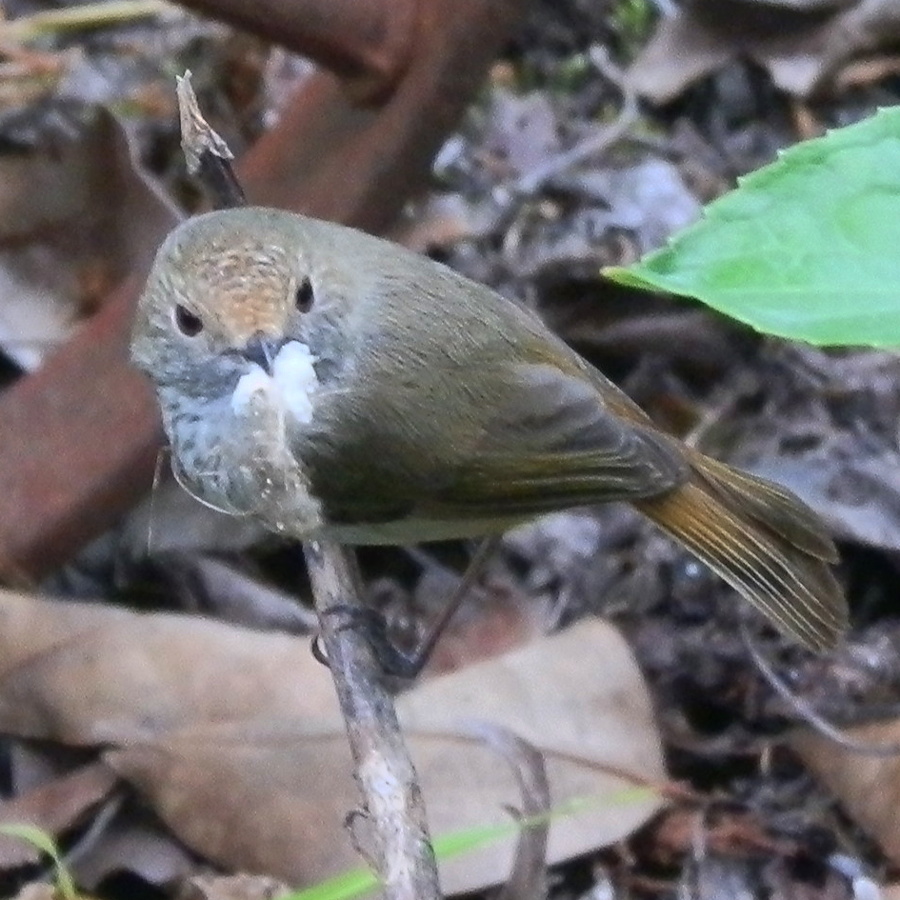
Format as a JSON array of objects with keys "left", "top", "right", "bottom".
[{"left": 181, "top": 0, "right": 419, "bottom": 102}]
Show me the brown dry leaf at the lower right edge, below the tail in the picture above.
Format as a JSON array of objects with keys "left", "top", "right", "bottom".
[{"left": 791, "top": 719, "right": 900, "bottom": 863}]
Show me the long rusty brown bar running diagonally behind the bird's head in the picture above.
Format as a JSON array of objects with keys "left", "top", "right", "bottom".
[{"left": 0, "top": 0, "right": 528, "bottom": 581}]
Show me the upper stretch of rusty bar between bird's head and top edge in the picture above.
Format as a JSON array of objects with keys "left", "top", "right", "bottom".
[{"left": 241, "top": 0, "right": 529, "bottom": 231}]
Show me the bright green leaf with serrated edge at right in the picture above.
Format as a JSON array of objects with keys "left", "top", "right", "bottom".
[{"left": 604, "top": 107, "right": 900, "bottom": 347}]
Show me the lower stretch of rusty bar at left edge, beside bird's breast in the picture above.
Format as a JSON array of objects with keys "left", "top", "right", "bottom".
[{"left": 0, "top": 280, "right": 160, "bottom": 584}]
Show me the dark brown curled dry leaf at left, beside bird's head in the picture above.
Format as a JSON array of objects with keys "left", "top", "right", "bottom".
[{"left": 0, "top": 109, "right": 179, "bottom": 369}]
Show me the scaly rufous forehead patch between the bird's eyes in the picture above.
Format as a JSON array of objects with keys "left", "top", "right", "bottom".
[{"left": 192, "top": 241, "right": 292, "bottom": 341}]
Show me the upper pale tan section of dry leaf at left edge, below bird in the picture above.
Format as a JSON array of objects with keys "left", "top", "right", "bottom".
[{"left": 0, "top": 591, "right": 334, "bottom": 745}]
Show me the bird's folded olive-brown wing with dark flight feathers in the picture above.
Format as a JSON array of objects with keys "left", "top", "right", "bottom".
[{"left": 421, "top": 363, "right": 689, "bottom": 518}]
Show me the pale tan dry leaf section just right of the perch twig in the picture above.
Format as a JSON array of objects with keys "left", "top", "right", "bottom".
[{"left": 398, "top": 619, "right": 666, "bottom": 892}]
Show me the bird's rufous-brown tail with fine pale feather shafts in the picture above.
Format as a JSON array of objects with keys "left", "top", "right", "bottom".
[{"left": 634, "top": 452, "right": 847, "bottom": 650}]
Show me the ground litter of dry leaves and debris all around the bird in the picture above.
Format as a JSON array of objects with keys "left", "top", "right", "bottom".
[{"left": 0, "top": 0, "right": 900, "bottom": 898}]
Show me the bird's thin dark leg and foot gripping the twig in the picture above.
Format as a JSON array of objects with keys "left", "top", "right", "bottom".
[{"left": 313, "top": 535, "right": 501, "bottom": 679}]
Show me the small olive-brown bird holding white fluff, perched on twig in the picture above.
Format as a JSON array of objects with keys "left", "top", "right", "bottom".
[{"left": 131, "top": 207, "right": 847, "bottom": 648}]
